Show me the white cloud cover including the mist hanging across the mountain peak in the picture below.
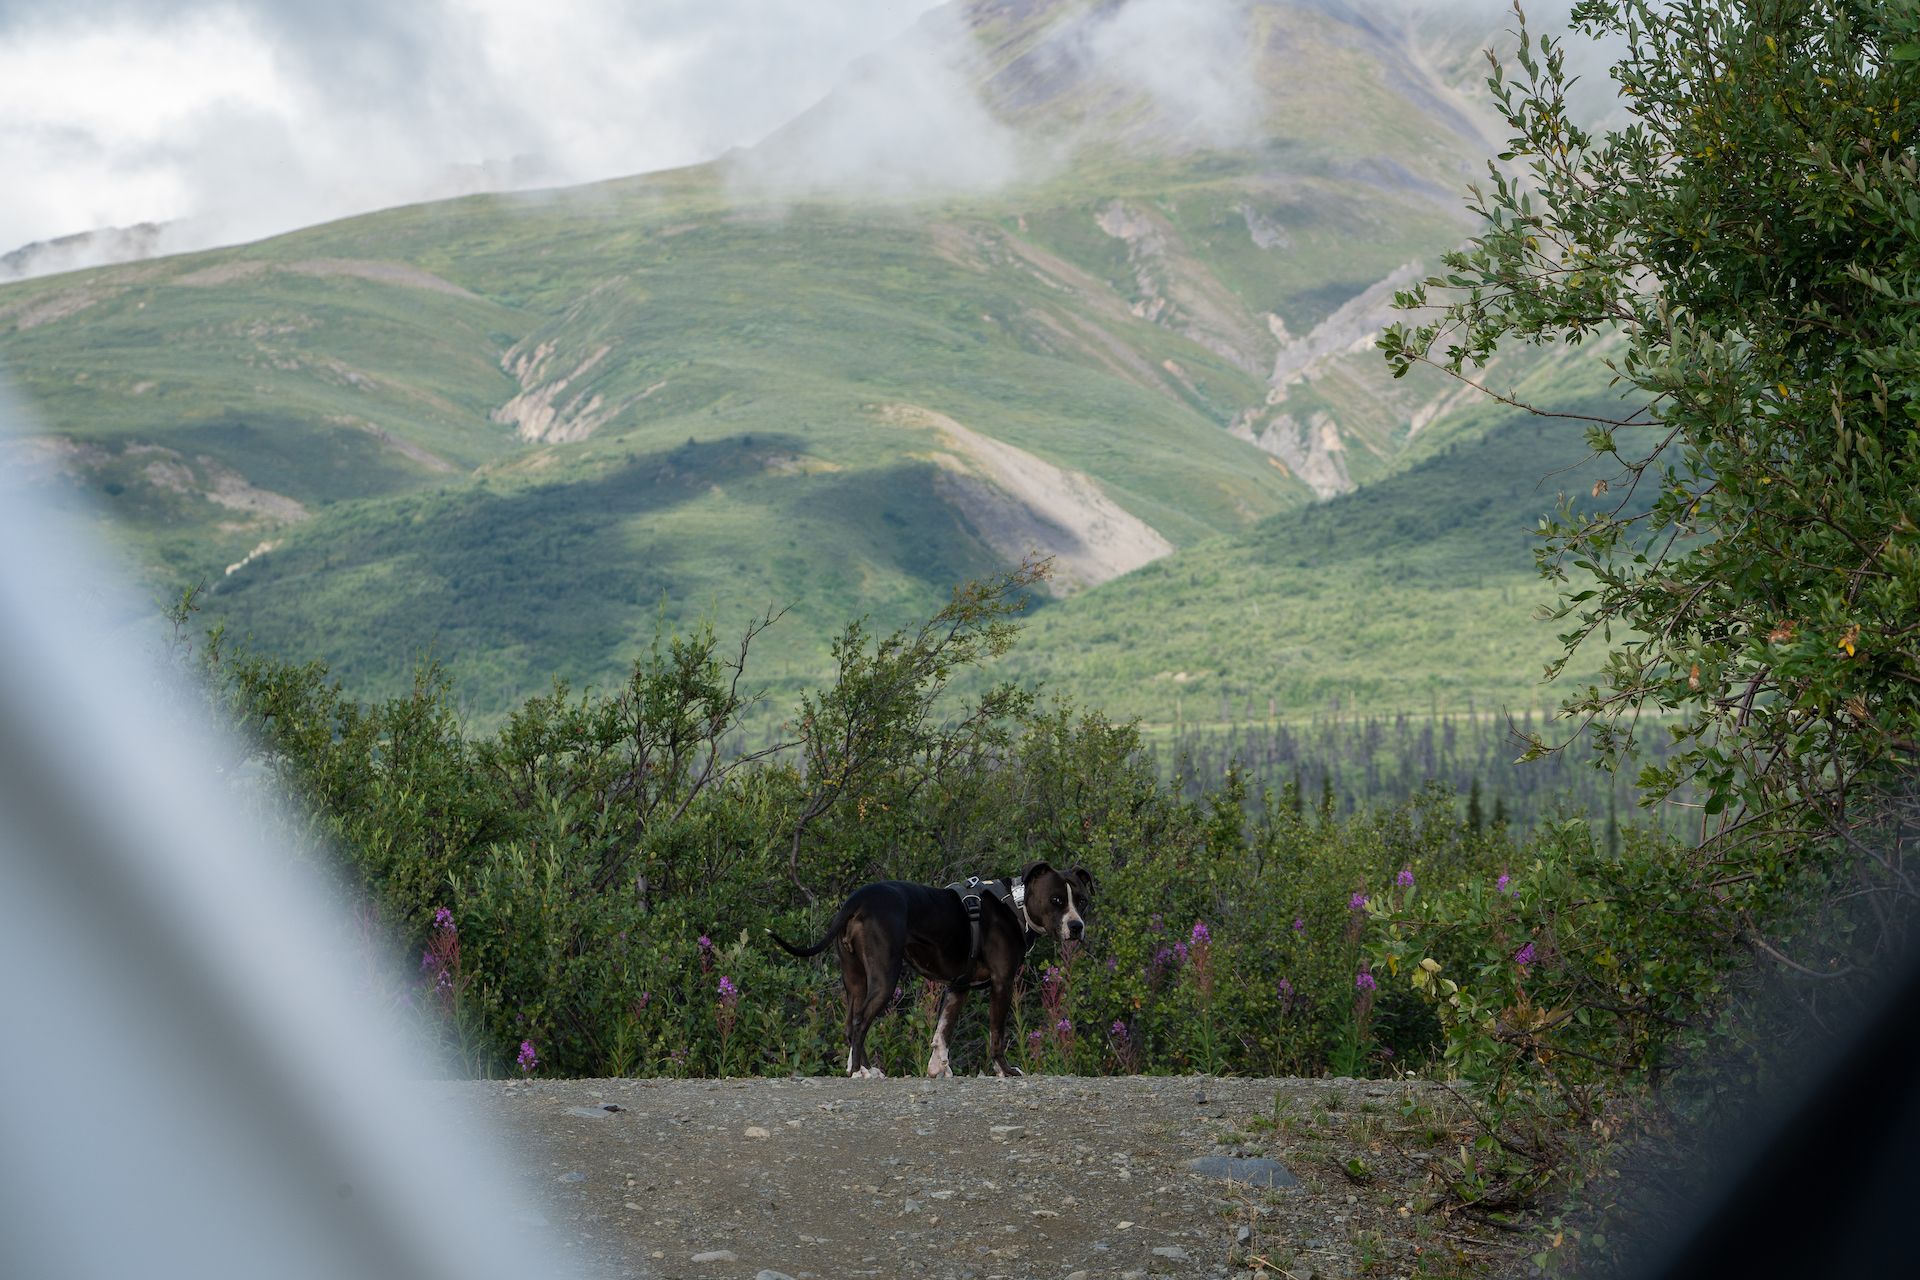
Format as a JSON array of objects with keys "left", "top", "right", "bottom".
[{"left": 0, "top": 0, "right": 1605, "bottom": 278}]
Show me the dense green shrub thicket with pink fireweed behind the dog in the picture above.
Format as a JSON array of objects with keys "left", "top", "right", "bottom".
[{"left": 213, "top": 580, "right": 1574, "bottom": 1075}]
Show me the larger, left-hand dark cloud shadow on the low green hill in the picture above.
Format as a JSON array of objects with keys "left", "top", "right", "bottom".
[{"left": 213, "top": 434, "right": 817, "bottom": 706}]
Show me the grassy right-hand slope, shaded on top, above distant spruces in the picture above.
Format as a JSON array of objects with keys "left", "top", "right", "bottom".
[{"left": 1008, "top": 359, "right": 1628, "bottom": 729}]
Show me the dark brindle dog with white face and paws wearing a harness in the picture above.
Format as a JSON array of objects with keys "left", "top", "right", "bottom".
[{"left": 768, "top": 862, "right": 1092, "bottom": 1077}]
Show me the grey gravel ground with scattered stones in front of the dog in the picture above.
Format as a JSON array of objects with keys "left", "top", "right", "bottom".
[{"left": 480, "top": 1077, "right": 1517, "bottom": 1280}]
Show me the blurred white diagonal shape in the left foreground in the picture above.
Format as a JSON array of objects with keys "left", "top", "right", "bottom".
[{"left": 0, "top": 383, "right": 572, "bottom": 1280}]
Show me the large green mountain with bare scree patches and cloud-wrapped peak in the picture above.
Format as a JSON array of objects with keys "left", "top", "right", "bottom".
[{"left": 0, "top": 0, "right": 1589, "bottom": 716}]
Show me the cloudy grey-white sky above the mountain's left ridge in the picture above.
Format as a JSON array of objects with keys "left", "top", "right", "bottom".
[{"left": 0, "top": 0, "right": 935, "bottom": 251}]
